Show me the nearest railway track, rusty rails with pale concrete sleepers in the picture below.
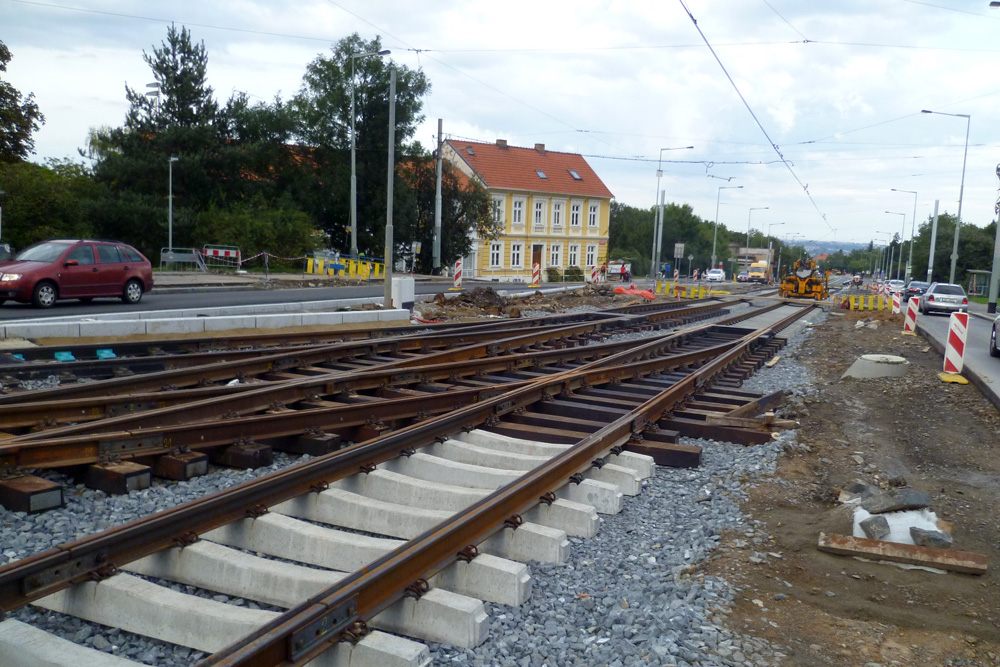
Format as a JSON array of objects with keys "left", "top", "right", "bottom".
[{"left": 0, "top": 307, "right": 808, "bottom": 665}]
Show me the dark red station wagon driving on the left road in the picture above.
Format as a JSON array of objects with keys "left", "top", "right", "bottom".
[{"left": 0, "top": 240, "right": 153, "bottom": 308}]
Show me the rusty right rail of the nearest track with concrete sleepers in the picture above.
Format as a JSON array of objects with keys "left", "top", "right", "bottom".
[{"left": 198, "top": 312, "right": 804, "bottom": 667}]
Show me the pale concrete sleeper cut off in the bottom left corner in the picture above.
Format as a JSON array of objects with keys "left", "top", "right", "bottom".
[{"left": 0, "top": 618, "right": 141, "bottom": 667}]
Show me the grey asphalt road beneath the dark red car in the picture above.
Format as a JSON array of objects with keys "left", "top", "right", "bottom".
[{"left": 0, "top": 282, "right": 458, "bottom": 321}]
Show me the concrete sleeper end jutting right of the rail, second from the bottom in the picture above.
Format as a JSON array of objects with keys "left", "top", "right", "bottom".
[{"left": 370, "top": 588, "right": 490, "bottom": 648}]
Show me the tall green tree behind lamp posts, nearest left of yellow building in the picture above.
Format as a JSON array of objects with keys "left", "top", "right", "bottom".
[{"left": 292, "top": 33, "right": 430, "bottom": 256}]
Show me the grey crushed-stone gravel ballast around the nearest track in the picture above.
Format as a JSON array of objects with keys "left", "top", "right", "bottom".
[{"left": 0, "top": 306, "right": 815, "bottom": 667}]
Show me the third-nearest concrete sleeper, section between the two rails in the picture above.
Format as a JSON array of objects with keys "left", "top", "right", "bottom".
[{"left": 123, "top": 540, "right": 346, "bottom": 609}]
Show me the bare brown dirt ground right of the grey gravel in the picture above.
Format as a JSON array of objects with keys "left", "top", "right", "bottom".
[{"left": 700, "top": 311, "right": 1000, "bottom": 666}]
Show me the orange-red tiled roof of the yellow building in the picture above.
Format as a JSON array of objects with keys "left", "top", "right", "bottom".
[{"left": 447, "top": 139, "right": 614, "bottom": 199}]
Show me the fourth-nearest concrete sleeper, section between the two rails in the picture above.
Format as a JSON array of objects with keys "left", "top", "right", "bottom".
[{"left": 204, "top": 513, "right": 403, "bottom": 572}]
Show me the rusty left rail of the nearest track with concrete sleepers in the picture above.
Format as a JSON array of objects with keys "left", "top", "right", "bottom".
[{"left": 0, "top": 302, "right": 800, "bottom": 614}]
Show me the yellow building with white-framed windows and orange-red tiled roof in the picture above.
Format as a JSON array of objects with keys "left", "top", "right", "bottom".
[{"left": 442, "top": 139, "right": 614, "bottom": 283}]
